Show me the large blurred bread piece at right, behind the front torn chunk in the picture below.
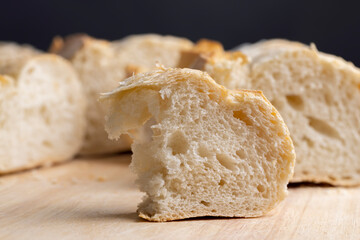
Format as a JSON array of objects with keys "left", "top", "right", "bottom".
[{"left": 187, "top": 40, "right": 360, "bottom": 186}]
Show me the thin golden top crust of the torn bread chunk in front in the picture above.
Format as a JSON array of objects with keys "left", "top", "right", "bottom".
[{"left": 99, "top": 66, "right": 278, "bottom": 141}]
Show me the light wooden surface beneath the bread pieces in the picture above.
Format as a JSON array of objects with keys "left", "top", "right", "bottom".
[{"left": 0, "top": 155, "right": 360, "bottom": 240}]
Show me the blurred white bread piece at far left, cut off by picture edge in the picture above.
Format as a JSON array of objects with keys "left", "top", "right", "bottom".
[{"left": 0, "top": 43, "right": 86, "bottom": 174}]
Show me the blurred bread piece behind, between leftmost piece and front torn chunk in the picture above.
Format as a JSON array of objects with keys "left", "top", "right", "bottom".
[{"left": 50, "top": 34, "right": 193, "bottom": 154}]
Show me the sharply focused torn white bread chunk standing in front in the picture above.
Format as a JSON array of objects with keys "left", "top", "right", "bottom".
[{"left": 102, "top": 68, "right": 295, "bottom": 221}]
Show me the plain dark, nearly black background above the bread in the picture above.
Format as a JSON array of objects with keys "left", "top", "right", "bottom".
[{"left": 0, "top": 0, "right": 360, "bottom": 66}]
